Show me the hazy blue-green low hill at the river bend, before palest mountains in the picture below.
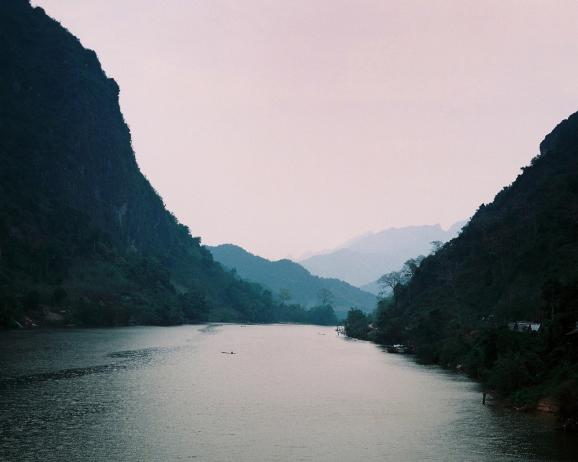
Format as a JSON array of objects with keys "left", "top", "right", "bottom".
[{"left": 209, "top": 244, "right": 377, "bottom": 313}]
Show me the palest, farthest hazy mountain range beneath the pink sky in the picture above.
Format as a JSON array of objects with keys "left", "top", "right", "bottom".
[{"left": 299, "top": 221, "right": 466, "bottom": 293}]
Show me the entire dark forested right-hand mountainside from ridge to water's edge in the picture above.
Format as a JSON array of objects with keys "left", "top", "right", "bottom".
[{"left": 342, "top": 114, "right": 578, "bottom": 430}]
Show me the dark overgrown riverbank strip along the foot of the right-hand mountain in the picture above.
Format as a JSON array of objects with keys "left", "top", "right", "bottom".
[{"left": 345, "top": 311, "right": 578, "bottom": 432}]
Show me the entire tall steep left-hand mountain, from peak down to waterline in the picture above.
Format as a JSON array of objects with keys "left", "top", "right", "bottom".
[{"left": 0, "top": 0, "right": 272, "bottom": 324}]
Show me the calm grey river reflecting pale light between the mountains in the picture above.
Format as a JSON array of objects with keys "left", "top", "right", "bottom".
[{"left": 0, "top": 325, "right": 578, "bottom": 462}]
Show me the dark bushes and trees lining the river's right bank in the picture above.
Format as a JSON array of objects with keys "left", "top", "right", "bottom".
[{"left": 345, "top": 292, "right": 578, "bottom": 430}]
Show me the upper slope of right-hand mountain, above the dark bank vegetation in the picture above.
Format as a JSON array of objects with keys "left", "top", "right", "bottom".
[{"left": 384, "top": 114, "right": 578, "bottom": 336}]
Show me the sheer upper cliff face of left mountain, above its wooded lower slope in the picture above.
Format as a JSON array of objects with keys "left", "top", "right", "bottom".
[{"left": 0, "top": 1, "right": 177, "bottom": 254}]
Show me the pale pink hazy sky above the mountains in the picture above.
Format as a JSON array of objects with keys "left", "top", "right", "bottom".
[{"left": 33, "top": 0, "right": 578, "bottom": 258}]
